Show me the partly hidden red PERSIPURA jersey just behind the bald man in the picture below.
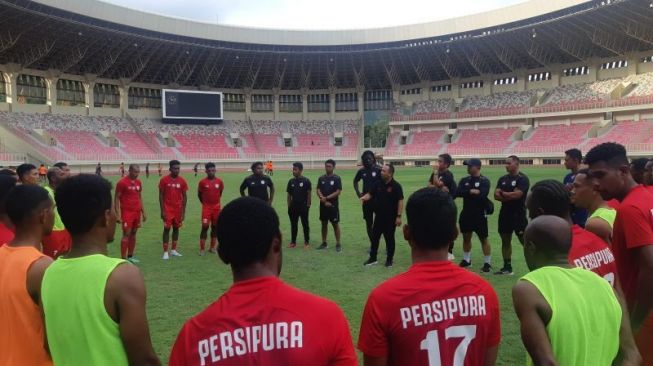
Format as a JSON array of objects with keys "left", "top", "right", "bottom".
[{"left": 567, "top": 225, "right": 617, "bottom": 287}]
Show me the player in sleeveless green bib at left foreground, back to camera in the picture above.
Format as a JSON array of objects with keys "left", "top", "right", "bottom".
[{"left": 41, "top": 174, "right": 160, "bottom": 366}]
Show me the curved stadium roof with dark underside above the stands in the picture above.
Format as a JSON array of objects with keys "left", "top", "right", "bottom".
[{"left": 0, "top": 0, "right": 653, "bottom": 90}]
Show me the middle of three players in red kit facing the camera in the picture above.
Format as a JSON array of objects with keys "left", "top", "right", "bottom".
[{"left": 159, "top": 160, "right": 188, "bottom": 260}]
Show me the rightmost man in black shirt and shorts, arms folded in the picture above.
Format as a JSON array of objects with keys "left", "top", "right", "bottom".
[{"left": 494, "top": 155, "right": 530, "bottom": 274}]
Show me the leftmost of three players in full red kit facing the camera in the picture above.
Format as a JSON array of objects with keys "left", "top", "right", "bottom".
[{"left": 114, "top": 164, "right": 147, "bottom": 263}]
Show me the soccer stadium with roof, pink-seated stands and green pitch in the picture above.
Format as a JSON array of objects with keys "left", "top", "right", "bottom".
[{"left": 0, "top": 0, "right": 653, "bottom": 366}]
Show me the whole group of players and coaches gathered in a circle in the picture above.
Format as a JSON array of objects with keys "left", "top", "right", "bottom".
[{"left": 0, "top": 143, "right": 653, "bottom": 366}]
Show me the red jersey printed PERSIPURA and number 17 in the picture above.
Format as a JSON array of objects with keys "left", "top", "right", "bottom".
[{"left": 358, "top": 261, "right": 501, "bottom": 366}]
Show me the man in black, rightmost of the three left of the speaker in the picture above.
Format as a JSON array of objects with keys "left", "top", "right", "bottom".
[{"left": 317, "top": 159, "right": 342, "bottom": 252}]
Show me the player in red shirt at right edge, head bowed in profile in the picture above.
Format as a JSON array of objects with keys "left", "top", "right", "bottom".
[{"left": 585, "top": 143, "right": 653, "bottom": 365}]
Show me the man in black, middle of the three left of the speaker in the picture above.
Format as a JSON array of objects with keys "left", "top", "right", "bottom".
[{"left": 286, "top": 162, "right": 311, "bottom": 249}]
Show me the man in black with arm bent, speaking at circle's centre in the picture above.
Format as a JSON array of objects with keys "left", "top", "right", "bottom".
[{"left": 361, "top": 164, "right": 404, "bottom": 267}]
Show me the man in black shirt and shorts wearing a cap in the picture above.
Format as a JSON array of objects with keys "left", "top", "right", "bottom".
[{"left": 456, "top": 158, "right": 492, "bottom": 273}]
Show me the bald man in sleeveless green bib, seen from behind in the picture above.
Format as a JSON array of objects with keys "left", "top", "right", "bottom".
[{"left": 512, "top": 215, "right": 640, "bottom": 365}]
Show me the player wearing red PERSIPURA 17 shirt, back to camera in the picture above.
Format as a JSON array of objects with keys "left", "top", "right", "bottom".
[{"left": 358, "top": 188, "right": 501, "bottom": 366}]
